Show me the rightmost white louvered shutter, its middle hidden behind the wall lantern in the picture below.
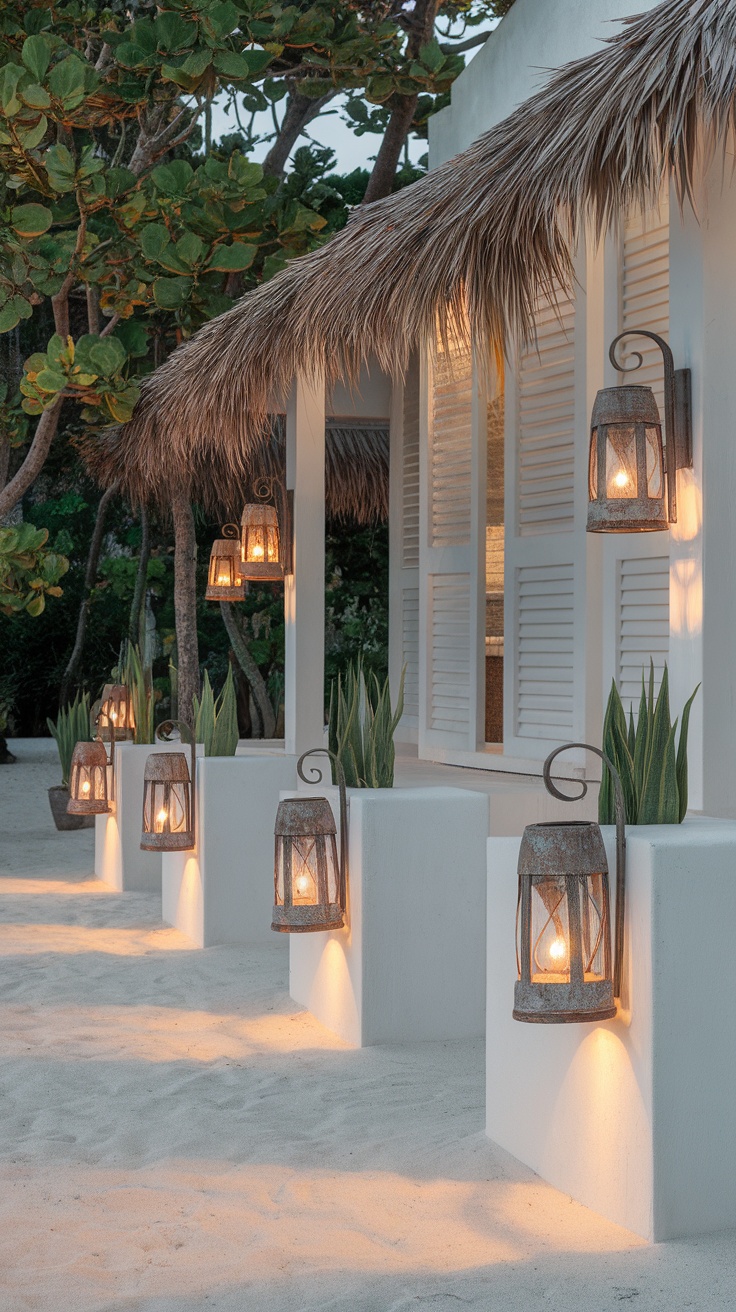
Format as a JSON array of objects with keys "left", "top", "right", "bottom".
[{"left": 603, "top": 195, "right": 669, "bottom": 710}]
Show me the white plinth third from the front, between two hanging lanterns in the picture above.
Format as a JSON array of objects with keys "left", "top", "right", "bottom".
[{"left": 161, "top": 750, "right": 296, "bottom": 947}]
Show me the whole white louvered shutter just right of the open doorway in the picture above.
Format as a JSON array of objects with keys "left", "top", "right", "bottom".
[{"left": 504, "top": 287, "right": 585, "bottom": 761}]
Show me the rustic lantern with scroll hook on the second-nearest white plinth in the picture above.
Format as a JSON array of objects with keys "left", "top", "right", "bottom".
[{"left": 272, "top": 748, "right": 348, "bottom": 934}]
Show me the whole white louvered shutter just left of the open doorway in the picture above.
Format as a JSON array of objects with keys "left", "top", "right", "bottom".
[{"left": 420, "top": 328, "right": 485, "bottom": 750}]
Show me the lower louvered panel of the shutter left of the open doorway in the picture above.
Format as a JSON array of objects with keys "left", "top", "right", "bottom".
[{"left": 429, "top": 573, "right": 470, "bottom": 733}]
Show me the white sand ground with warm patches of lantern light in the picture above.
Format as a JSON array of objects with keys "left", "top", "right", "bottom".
[{"left": 0, "top": 743, "right": 736, "bottom": 1312}]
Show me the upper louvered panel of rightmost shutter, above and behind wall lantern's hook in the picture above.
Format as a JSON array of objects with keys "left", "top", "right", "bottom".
[{"left": 621, "top": 198, "right": 669, "bottom": 420}]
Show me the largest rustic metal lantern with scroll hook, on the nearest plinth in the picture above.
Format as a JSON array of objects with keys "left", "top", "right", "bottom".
[{"left": 513, "top": 743, "right": 626, "bottom": 1025}]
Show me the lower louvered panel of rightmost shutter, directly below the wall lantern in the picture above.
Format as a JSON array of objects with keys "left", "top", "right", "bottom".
[{"left": 617, "top": 556, "right": 669, "bottom": 711}]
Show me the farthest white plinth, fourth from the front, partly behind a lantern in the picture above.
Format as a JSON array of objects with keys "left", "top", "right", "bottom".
[{"left": 94, "top": 743, "right": 178, "bottom": 892}]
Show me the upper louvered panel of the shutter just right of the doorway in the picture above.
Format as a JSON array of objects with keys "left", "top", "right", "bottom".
[{"left": 517, "top": 297, "right": 575, "bottom": 537}]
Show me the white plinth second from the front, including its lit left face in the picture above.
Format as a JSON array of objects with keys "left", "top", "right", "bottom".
[{"left": 289, "top": 789, "right": 488, "bottom": 1047}]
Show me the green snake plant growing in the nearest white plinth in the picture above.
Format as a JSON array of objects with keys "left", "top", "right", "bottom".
[{"left": 598, "top": 661, "right": 701, "bottom": 824}]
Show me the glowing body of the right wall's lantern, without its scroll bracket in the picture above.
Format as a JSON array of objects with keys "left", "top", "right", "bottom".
[{"left": 588, "top": 384, "right": 669, "bottom": 533}]
